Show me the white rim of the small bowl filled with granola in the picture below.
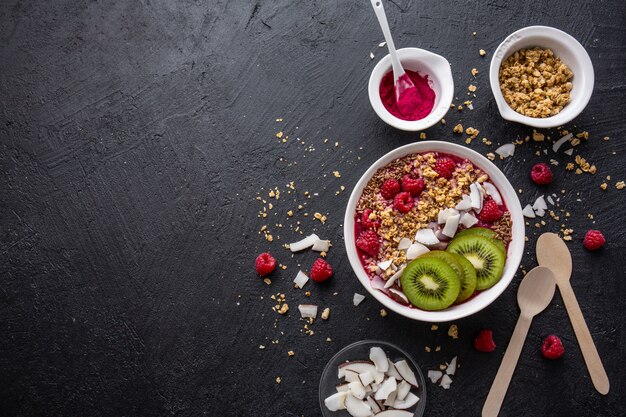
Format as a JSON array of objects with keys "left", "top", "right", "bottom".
[{"left": 489, "top": 25, "right": 595, "bottom": 128}]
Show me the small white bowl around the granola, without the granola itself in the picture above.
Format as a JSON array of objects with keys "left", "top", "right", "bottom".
[{"left": 489, "top": 26, "right": 594, "bottom": 128}]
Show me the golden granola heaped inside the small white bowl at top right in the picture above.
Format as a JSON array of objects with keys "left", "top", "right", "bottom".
[{"left": 499, "top": 48, "right": 574, "bottom": 118}]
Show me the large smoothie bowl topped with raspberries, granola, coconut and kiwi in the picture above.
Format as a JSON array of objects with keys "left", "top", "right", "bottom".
[{"left": 344, "top": 141, "right": 524, "bottom": 322}]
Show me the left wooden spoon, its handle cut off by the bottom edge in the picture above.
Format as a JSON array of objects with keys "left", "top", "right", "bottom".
[{"left": 482, "top": 266, "right": 556, "bottom": 417}]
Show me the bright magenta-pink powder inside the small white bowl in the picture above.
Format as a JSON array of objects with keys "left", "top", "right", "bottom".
[{"left": 379, "top": 70, "right": 436, "bottom": 121}]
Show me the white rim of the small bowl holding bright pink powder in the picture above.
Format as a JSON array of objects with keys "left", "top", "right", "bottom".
[{"left": 367, "top": 48, "right": 454, "bottom": 132}]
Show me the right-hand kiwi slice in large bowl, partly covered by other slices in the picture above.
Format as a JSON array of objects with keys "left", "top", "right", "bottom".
[{"left": 447, "top": 235, "right": 506, "bottom": 290}]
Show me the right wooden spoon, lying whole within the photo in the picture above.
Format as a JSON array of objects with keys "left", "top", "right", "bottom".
[{"left": 537, "top": 233, "right": 610, "bottom": 395}]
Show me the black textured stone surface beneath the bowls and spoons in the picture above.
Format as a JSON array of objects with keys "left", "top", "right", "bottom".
[{"left": 0, "top": 0, "right": 626, "bottom": 417}]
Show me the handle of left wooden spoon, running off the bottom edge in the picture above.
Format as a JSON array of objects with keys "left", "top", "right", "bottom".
[{"left": 482, "top": 315, "right": 532, "bottom": 417}]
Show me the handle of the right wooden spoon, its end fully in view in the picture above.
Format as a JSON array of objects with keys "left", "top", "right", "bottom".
[{"left": 559, "top": 282, "right": 610, "bottom": 395}]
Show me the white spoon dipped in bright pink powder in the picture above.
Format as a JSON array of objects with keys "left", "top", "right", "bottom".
[{"left": 370, "top": 0, "right": 419, "bottom": 115}]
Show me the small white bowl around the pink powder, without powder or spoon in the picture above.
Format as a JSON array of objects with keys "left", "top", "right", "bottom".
[{"left": 368, "top": 48, "right": 454, "bottom": 132}]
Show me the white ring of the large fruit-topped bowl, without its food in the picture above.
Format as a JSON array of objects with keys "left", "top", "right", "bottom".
[{"left": 343, "top": 141, "right": 525, "bottom": 322}]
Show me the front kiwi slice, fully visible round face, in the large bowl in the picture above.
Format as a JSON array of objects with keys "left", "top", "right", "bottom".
[{"left": 400, "top": 257, "right": 461, "bottom": 310}]
